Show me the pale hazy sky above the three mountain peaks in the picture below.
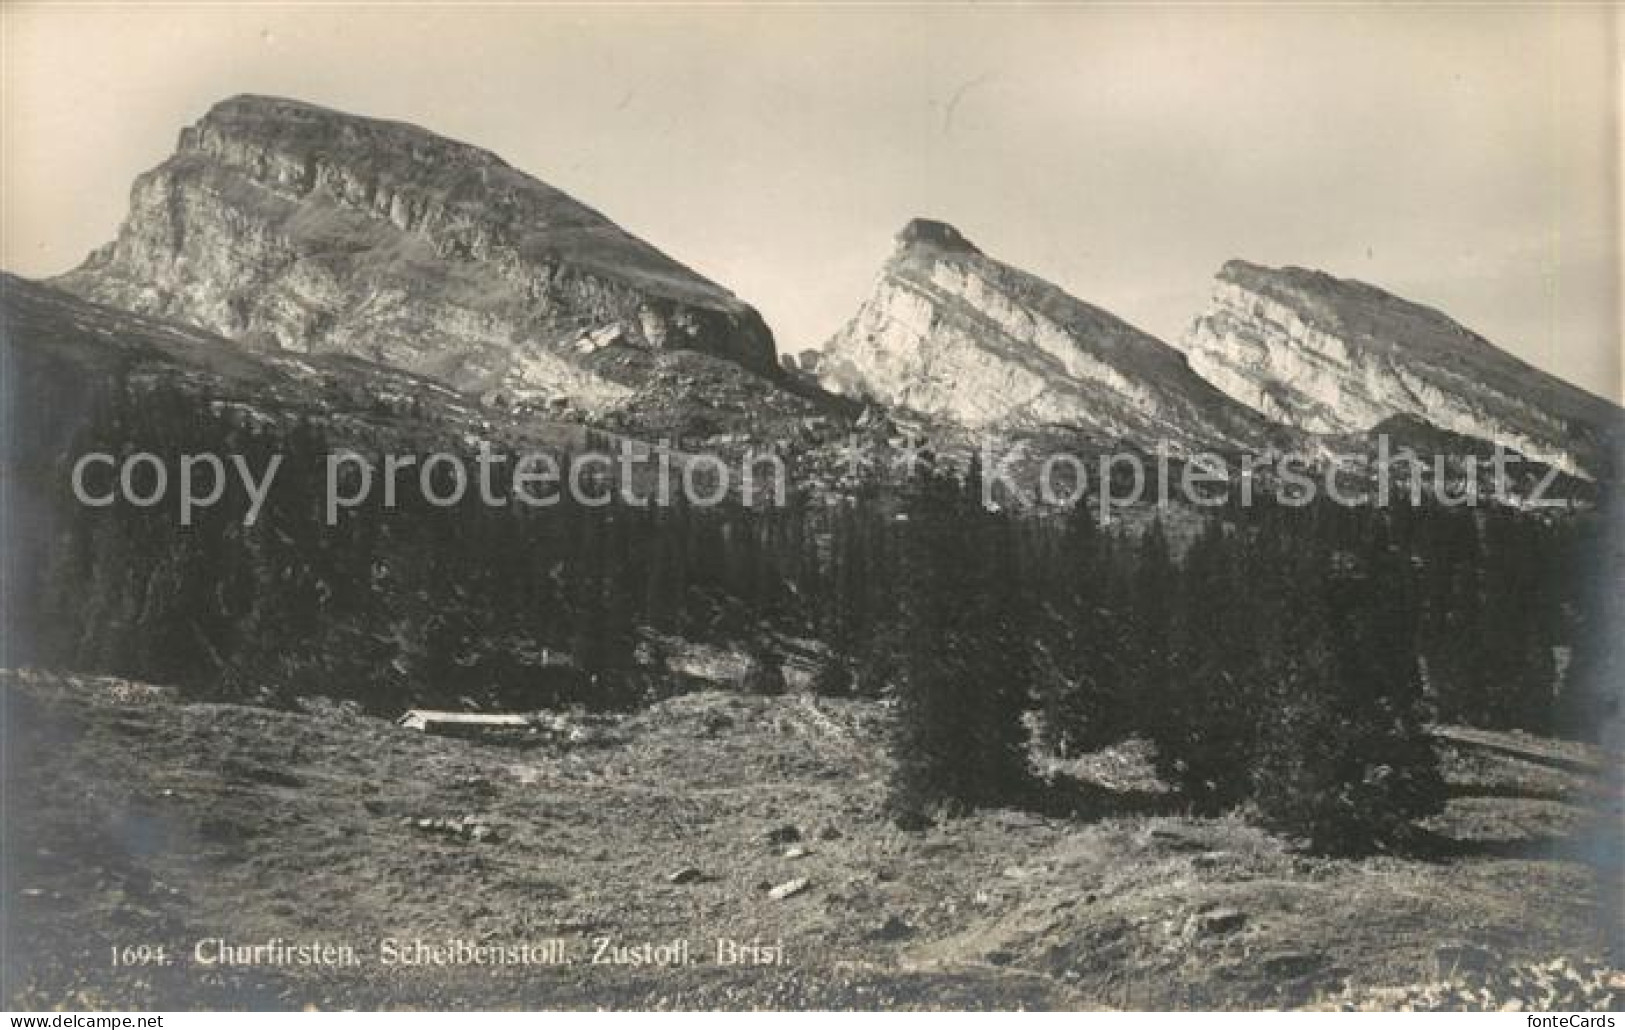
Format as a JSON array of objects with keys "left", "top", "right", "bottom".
[{"left": 0, "top": 0, "right": 1625, "bottom": 400}]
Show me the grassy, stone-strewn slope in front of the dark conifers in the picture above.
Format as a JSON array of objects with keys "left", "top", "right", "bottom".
[{"left": 0, "top": 674, "right": 1617, "bottom": 1007}]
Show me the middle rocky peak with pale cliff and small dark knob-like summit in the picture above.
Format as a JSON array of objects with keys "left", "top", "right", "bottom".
[{"left": 817, "top": 221, "right": 1271, "bottom": 450}]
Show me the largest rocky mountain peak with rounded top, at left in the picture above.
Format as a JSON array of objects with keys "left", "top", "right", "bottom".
[{"left": 57, "top": 96, "right": 777, "bottom": 408}]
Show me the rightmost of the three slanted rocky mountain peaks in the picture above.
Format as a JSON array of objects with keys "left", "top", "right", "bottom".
[{"left": 1183, "top": 262, "right": 1625, "bottom": 478}]
